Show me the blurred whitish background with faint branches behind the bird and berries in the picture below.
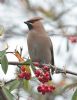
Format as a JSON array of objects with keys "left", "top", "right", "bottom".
[{"left": 0, "top": 0, "right": 77, "bottom": 100}]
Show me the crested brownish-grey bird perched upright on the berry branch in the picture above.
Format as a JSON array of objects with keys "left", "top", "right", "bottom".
[{"left": 24, "top": 17, "right": 54, "bottom": 75}]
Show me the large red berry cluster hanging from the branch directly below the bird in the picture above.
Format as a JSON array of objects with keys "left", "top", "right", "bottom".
[{"left": 35, "top": 66, "right": 51, "bottom": 83}]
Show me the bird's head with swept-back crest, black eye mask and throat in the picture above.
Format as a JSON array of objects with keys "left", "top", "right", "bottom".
[{"left": 24, "top": 17, "right": 43, "bottom": 30}]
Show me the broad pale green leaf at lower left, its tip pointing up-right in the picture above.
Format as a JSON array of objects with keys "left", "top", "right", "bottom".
[{"left": 6, "top": 80, "right": 20, "bottom": 91}]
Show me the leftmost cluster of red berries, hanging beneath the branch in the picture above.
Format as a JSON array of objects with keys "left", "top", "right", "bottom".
[{"left": 18, "top": 66, "right": 31, "bottom": 80}]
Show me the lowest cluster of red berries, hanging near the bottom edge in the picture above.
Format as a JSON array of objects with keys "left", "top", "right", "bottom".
[{"left": 37, "top": 84, "right": 55, "bottom": 95}]
